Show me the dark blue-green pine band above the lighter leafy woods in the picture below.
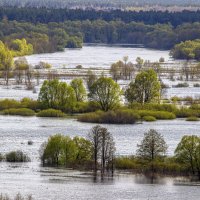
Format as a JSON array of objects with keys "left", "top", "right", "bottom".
[{"left": 0, "top": 7, "right": 200, "bottom": 26}]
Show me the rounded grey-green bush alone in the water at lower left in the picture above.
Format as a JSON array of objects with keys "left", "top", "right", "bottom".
[{"left": 6, "top": 151, "right": 30, "bottom": 162}]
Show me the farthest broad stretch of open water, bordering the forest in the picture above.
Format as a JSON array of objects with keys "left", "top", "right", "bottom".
[{"left": 26, "top": 44, "right": 172, "bottom": 68}]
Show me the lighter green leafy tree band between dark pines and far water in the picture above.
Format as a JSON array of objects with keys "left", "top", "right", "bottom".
[{"left": 0, "top": 17, "right": 200, "bottom": 50}]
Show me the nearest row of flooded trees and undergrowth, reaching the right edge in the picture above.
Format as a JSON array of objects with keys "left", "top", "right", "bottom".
[{"left": 40, "top": 125, "right": 200, "bottom": 180}]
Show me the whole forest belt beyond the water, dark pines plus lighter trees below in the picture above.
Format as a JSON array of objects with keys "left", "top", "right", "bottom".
[{"left": 0, "top": 7, "right": 200, "bottom": 53}]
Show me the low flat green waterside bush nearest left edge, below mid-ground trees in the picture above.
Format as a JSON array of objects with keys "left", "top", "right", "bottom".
[{"left": 3, "top": 108, "right": 35, "bottom": 116}]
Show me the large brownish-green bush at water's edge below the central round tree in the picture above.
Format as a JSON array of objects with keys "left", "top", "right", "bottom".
[{"left": 78, "top": 109, "right": 140, "bottom": 124}]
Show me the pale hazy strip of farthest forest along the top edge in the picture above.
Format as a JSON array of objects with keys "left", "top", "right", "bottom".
[{"left": 0, "top": 0, "right": 200, "bottom": 8}]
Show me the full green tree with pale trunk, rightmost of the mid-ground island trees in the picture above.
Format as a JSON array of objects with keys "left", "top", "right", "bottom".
[{"left": 125, "top": 69, "right": 161, "bottom": 104}]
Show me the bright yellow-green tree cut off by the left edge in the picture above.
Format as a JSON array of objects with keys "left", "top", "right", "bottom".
[{"left": 0, "top": 41, "right": 13, "bottom": 85}]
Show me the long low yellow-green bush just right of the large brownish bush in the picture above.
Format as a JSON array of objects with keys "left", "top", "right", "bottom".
[{"left": 137, "top": 110, "right": 176, "bottom": 119}]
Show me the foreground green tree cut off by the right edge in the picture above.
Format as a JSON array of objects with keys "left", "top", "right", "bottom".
[{"left": 175, "top": 135, "right": 200, "bottom": 180}]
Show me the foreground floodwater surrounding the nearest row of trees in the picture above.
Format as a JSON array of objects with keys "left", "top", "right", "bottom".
[{"left": 0, "top": 116, "right": 200, "bottom": 200}]
